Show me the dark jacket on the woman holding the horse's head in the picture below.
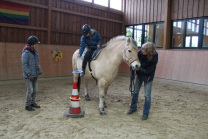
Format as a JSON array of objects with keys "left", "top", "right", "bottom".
[{"left": 136, "top": 49, "right": 158, "bottom": 82}]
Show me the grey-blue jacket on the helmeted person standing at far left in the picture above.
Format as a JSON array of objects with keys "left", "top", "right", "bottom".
[{"left": 21, "top": 45, "right": 41, "bottom": 79}]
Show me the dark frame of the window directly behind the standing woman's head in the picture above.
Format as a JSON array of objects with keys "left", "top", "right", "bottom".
[{"left": 125, "top": 22, "right": 164, "bottom": 48}]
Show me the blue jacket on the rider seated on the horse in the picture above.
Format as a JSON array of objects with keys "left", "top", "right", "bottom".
[{"left": 79, "top": 29, "right": 102, "bottom": 55}]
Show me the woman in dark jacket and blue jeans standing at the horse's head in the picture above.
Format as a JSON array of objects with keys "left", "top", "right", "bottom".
[{"left": 127, "top": 42, "right": 158, "bottom": 120}]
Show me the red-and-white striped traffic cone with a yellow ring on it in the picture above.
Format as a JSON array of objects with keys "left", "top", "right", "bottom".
[{"left": 65, "top": 81, "right": 85, "bottom": 118}]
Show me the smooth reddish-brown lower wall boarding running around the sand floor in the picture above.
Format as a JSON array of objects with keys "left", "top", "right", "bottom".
[{"left": 0, "top": 43, "right": 208, "bottom": 85}]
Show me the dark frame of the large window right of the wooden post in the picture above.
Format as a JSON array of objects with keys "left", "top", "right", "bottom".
[{"left": 170, "top": 17, "right": 208, "bottom": 49}]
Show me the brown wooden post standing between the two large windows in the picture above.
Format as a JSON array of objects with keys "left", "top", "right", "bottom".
[{"left": 163, "top": 0, "right": 171, "bottom": 49}]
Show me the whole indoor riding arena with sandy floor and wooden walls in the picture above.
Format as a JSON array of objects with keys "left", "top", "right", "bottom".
[{"left": 0, "top": 0, "right": 208, "bottom": 139}]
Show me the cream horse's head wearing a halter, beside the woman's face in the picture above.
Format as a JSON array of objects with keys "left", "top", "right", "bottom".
[{"left": 123, "top": 38, "right": 141, "bottom": 70}]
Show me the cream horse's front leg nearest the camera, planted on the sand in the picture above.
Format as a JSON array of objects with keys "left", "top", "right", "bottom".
[{"left": 98, "top": 80, "right": 106, "bottom": 115}]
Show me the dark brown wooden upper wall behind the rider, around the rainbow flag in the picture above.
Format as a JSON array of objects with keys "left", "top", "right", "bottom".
[{"left": 0, "top": 0, "right": 123, "bottom": 45}]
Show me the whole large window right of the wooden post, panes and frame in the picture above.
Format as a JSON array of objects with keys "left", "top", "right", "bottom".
[{"left": 171, "top": 17, "right": 208, "bottom": 49}]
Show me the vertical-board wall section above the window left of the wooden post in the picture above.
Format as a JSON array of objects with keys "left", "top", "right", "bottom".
[{"left": 124, "top": 0, "right": 165, "bottom": 25}]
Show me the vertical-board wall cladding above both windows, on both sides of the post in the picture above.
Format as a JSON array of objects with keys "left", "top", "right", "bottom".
[{"left": 125, "top": 0, "right": 208, "bottom": 25}]
